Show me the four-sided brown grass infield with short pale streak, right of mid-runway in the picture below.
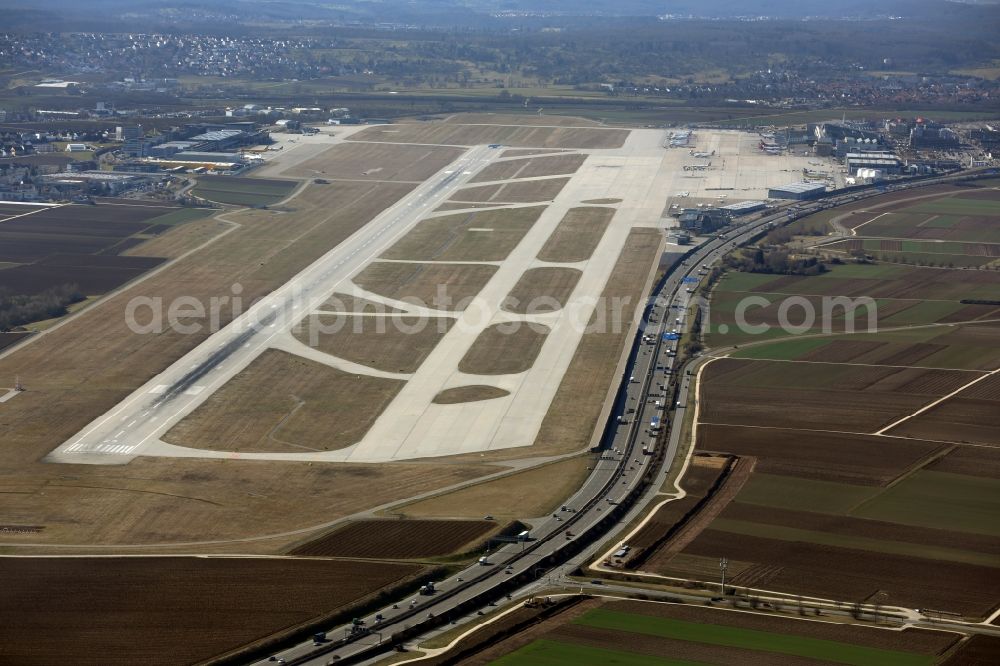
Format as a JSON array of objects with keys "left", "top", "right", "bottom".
[{"left": 381, "top": 206, "right": 545, "bottom": 261}]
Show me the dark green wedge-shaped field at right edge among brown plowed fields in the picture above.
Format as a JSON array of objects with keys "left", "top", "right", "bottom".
[{"left": 850, "top": 470, "right": 1000, "bottom": 536}]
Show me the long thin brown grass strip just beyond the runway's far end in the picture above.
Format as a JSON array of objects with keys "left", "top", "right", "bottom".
[{"left": 351, "top": 121, "right": 628, "bottom": 148}]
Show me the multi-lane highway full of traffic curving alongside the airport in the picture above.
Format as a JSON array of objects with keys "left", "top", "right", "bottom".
[{"left": 244, "top": 165, "right": 1000, "bottom": 666}]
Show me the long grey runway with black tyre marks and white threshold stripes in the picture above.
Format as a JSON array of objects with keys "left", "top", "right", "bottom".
[{"left": 45, "top": 146, "right": 500, "bottom": 464}]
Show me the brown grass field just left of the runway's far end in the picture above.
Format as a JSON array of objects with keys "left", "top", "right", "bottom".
[{"left": 282, "top": 142, "right": 462, "bottom": 182}]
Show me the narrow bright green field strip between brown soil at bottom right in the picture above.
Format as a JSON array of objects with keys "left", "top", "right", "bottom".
[{"left": 575, "top": 608, "right": 934, "bottom": 666}]
